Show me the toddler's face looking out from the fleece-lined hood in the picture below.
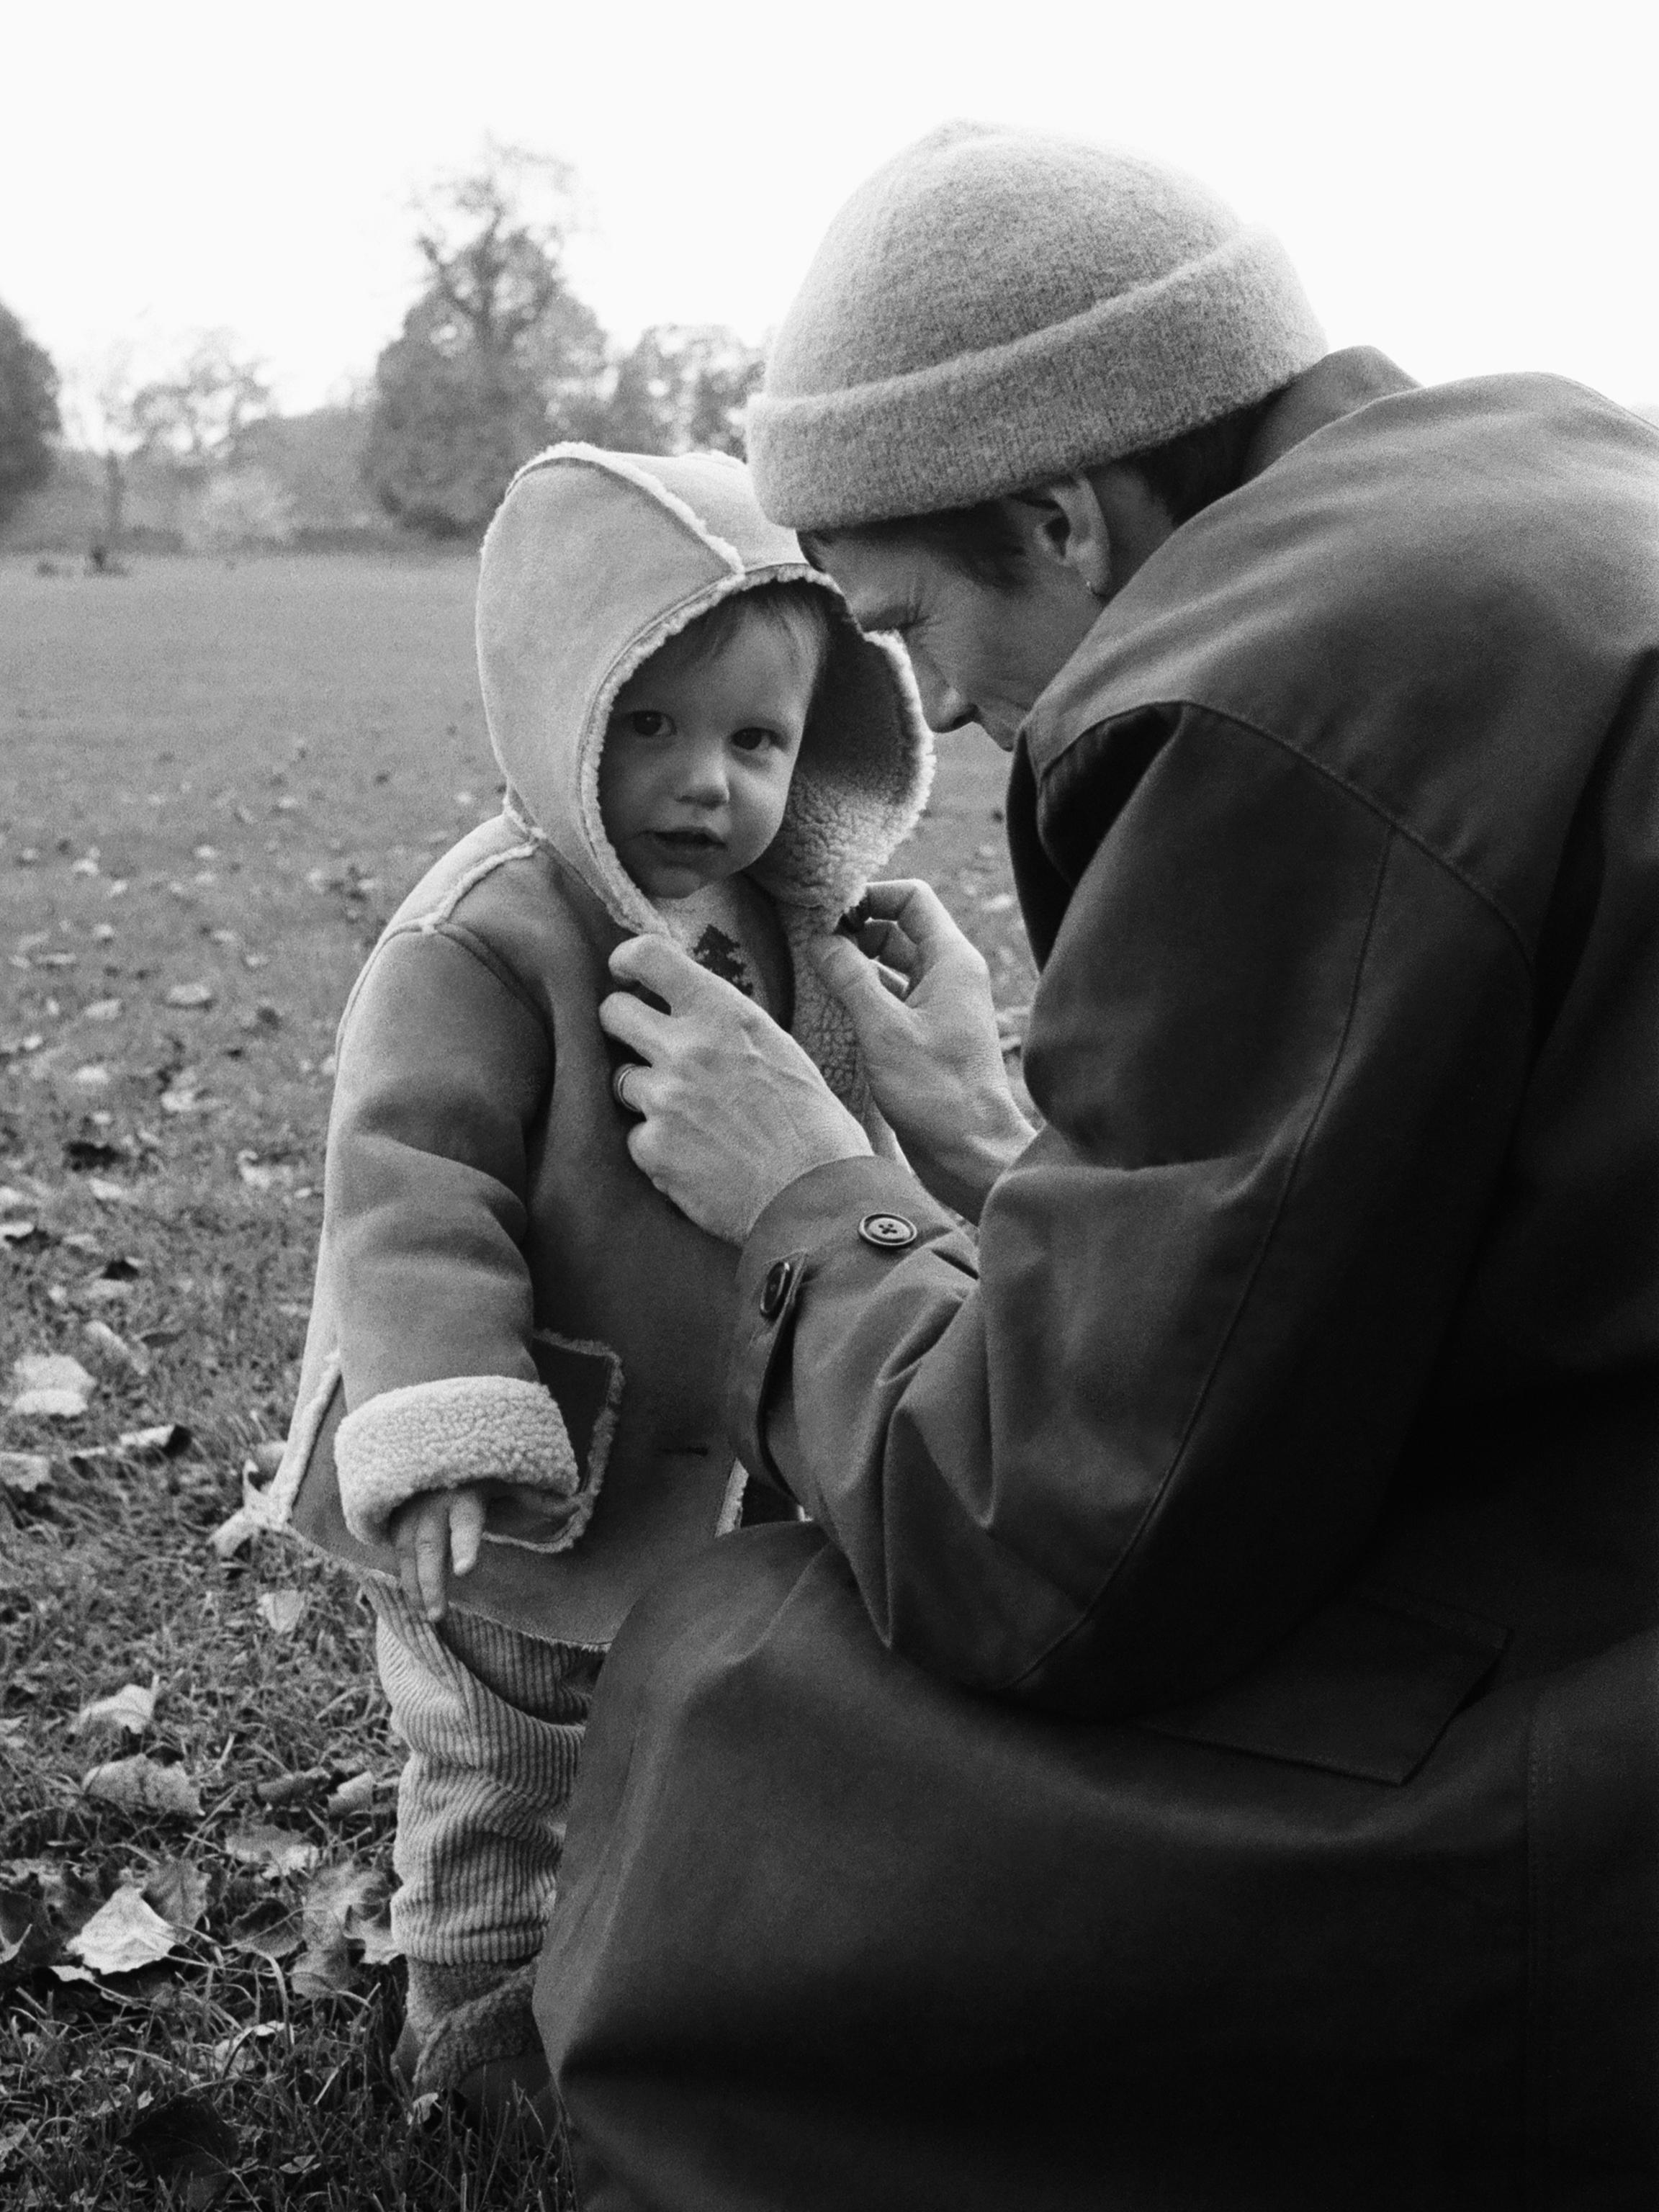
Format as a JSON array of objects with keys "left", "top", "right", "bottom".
[{"left": 600, "top": 619, "right": 817, "bottom": 898}]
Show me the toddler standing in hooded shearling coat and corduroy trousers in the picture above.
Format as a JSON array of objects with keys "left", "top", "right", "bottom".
[{"left": 266, "top": 444, "right": 931, "bottom": 2108}]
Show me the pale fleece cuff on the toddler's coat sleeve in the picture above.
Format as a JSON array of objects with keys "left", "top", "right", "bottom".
[{"left": 334, "top": 1376, "right": 582, "bottom": 1544}]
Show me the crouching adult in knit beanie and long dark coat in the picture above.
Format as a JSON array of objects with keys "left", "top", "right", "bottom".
[{"left": 537, "top": 126, "right": 1659, "bottom": 2212}]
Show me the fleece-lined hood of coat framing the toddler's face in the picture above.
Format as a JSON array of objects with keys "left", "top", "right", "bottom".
[{"left": 478, "top": 444, "right": 933, "bottom": 938}]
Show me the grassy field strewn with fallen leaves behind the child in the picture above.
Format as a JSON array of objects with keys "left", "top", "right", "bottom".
[{"left": 0, "top": 557, "right": 1031, "bottom": 2212}]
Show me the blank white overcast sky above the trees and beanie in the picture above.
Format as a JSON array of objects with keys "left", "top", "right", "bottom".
[{"left": 0, "top": 0, "right": 1659, "bottom": 409}]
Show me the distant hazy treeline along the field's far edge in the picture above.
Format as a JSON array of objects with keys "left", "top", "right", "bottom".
[{"left": 0, "top": 144, "right": 761, "bottom": 566}]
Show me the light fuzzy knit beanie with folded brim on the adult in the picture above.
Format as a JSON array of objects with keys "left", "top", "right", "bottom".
[{"left": 747, "top": 122, "right": 1325, "bottom": 531}]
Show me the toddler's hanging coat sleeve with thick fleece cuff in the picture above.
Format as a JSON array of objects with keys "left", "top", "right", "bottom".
[{"left": 323, "top": 925, "right": 577, "bottom": 1542}]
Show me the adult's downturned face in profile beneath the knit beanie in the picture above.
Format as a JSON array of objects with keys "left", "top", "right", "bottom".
[{"left": 819, "top": 533, "right": 1100, "bottom": 752}]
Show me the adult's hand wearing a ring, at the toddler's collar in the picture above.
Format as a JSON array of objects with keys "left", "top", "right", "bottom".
[{"left": 600, "top": 938, "right": 869, "bottom": 1243}]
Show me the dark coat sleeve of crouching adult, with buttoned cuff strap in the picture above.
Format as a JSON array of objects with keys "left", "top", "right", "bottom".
[{"left": 732, "top": 710, "right": 1531, "bottom": 1717}]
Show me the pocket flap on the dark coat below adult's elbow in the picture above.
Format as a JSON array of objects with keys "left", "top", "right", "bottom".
[{"left": 1137, "top": 1588, "right": 1509, "bottom": 1785}]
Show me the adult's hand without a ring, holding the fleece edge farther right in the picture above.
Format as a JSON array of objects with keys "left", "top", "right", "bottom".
[{"left": 814, "top": 883, "right": 1035, "bottom": 1221}]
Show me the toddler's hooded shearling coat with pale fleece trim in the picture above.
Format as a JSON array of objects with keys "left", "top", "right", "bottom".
[{"left": 264, "top": 444, "right": 931, "bottom": 1643}]
